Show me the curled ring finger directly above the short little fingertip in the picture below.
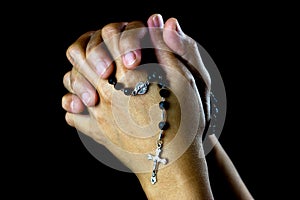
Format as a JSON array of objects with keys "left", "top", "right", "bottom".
[{"left": 63, "top": 68, "right": 99, "bottom": 106}]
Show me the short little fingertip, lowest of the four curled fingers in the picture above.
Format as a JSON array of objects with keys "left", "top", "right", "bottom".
[{"left": 61, "top": 93, "right": 85, "bottom": 113}]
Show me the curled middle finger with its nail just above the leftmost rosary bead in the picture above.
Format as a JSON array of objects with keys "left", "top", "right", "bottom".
[{"left": 86, "top": 29, "right": 114, "bottom": 79}]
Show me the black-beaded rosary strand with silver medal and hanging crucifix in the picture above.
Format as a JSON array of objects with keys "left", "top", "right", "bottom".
[{"left": 108, "top": 72, "right": 170, "bottom": 184}]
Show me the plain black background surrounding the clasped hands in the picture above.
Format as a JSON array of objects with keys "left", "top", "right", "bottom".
[{"left": 2, "top": 1, "right": 294, "bottom": 199}]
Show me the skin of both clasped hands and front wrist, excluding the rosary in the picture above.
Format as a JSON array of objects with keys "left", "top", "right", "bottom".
[{"left": 62, "top": 14, "right": 253, "bottom": 199}]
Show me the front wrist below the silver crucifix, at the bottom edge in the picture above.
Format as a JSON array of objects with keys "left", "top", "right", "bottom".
[{"left": 136, "top": 141, "right": 213, "bottom": 200}]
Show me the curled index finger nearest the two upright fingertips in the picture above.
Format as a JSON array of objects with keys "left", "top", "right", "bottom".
[{"left": 119, "top": 21, "right": 147, "bottom": 69}]
